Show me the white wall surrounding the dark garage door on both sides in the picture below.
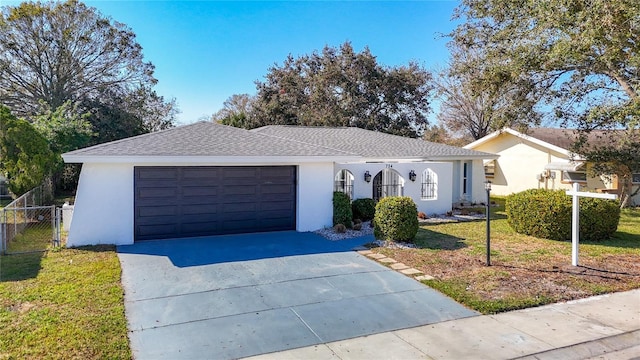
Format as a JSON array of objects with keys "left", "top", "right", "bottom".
[{"left": 67, "top": 162, "right": 334, "bottom": 247}]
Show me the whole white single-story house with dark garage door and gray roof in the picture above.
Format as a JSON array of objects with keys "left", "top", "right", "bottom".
[{"left": 63, "top": 122, "right": 496, "bottom": 246}]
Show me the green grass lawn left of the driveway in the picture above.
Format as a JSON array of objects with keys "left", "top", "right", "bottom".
[{"left": 0, "top": 246, "right": 131, "bottom": 359}]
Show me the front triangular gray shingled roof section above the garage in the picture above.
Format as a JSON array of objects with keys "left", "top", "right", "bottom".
[{"left": 65, "top": 121, "right": 353, "bottom": 156}]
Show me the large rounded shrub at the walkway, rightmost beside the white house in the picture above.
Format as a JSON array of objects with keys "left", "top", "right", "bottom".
[{"left": 373, "top": 196, "right": 418, "bottom": 242}]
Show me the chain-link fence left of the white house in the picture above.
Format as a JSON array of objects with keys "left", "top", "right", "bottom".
[{"left": 0, "top": 186, "right": 60, "bottom": 254}]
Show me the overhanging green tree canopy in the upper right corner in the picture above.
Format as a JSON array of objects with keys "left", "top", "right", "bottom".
[{"left": 451, "top": 0, "right": 640, "bottom": 207}]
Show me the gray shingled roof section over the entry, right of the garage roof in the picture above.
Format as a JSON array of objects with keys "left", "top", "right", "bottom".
[{"left": 251, "top": 125, "right": 496, "bottom": 160}]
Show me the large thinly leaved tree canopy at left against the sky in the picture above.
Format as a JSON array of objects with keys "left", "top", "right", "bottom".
[{"left": 0, "top": 0, "right": 177, "bottom": 143}]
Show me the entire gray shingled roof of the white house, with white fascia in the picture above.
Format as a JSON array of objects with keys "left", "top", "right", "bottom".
[{"left": 63, "top": 122, "right": 497, "bottom": 162}]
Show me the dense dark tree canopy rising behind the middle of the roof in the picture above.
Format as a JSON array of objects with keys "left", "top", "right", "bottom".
[{"left": 246, "top": 42, "right": 433, "bottom": 137}]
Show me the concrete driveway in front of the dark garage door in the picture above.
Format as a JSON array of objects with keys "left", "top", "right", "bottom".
[{"left": 118, "top": 232, "right": 477, "bottom": 359}]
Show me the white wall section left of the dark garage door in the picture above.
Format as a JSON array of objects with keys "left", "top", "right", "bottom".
[{"left": 67, "top": 164, "right": 133, "bottom": 247}]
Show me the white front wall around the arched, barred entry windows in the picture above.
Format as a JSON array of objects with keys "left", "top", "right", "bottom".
[{"left": 331, "top": 162, "right": 458, "bottom": 215}]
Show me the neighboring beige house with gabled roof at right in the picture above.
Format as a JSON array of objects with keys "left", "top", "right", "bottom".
[{"left": 464, "top": 128, "right": 640, "bottom": 205}]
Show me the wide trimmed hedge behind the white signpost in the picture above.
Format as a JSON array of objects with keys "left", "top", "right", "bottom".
[{"left": 505, "top": 189, "right": 620, "bottom": 241}]
